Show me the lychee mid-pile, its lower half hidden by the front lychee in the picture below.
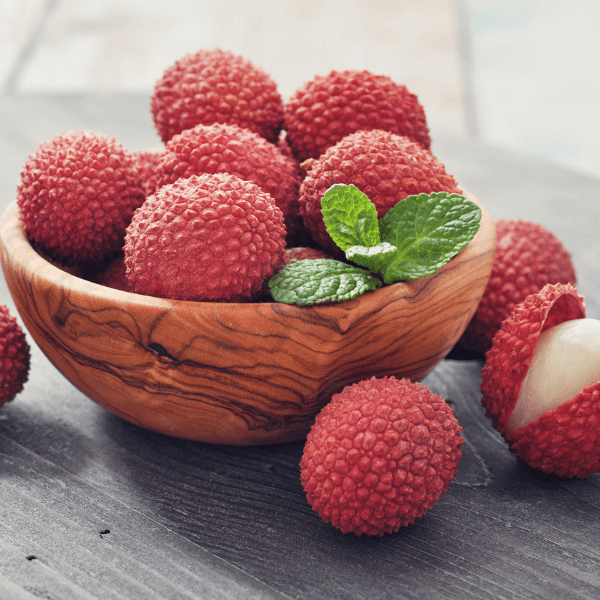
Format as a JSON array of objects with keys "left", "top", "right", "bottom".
[{"left": 157, "top": 123, "right": 300, "bottom": 231}]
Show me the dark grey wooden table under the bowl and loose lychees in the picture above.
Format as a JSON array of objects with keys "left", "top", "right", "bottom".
[{"left": 0, "top": 96, "right": 600, "bottom": 600}]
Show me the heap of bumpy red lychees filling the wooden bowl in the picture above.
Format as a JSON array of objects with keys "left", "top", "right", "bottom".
[{"left": 18, "top": 50, "right": 461, "bottom": 302}]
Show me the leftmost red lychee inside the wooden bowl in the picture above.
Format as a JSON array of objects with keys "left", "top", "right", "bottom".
[{"left": 17, "top": 131, "right": 144, "bottom": 265}]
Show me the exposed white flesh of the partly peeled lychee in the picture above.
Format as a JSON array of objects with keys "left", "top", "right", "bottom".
[{"left": 508, "top": 319, "right": 600, "bottom": 433}]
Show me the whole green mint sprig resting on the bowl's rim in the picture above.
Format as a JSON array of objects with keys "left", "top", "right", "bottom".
[{"left": 269, "top": 184, "right": 481, "bottom": 305}]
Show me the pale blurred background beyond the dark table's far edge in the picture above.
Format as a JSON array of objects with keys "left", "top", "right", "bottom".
[{"left": 0, "top": 0, "right": 600, "bottom": 176}]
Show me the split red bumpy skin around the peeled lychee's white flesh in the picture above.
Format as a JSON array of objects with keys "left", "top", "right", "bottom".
[{"left": 481, "top": 284, "right": 600, "bottom": 477}]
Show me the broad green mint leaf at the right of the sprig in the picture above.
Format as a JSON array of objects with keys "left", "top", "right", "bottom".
[{"left": 379, "top": 192, "right": 481, "bottom": 283}]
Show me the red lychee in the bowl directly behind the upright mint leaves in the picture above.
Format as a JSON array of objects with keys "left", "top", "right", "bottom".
[{"left": 298, "top": 130, "right": 461, "bottom": 252}]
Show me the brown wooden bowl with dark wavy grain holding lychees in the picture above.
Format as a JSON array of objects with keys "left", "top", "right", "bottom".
[{"left": 0, "top": 204, "right": 496, "bottom": 444}]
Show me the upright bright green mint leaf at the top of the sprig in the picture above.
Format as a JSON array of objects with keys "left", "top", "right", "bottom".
[{"left": 321, "top": 183, "right": 379, "bottom": 252}]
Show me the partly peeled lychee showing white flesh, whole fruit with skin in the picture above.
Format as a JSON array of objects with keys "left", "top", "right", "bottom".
[{"left": 481, "top": 283, "right": 600, "bottom": 477}]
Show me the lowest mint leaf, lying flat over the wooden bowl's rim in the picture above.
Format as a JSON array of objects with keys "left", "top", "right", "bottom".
[{"left": 269, "top": 258, "right": 381, "bottom": 306}]
